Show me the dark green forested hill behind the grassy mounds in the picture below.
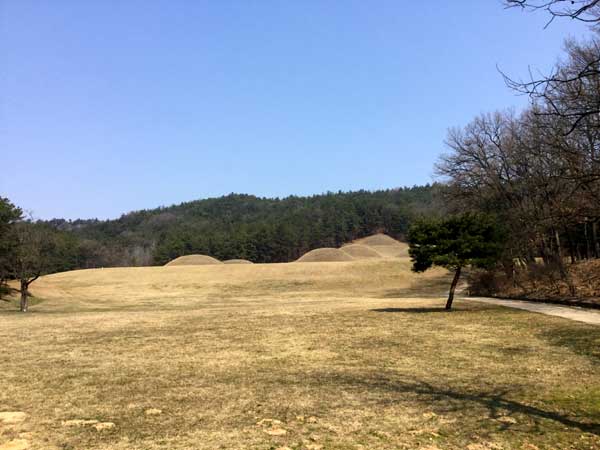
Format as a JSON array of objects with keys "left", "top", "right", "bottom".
[{"left": 48, "top": 185, "right": 438, "bottom": 269}]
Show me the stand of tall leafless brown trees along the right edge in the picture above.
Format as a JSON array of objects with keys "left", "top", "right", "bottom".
[{"left": 437, "top": 29, "right": 600, "bottom": 295}]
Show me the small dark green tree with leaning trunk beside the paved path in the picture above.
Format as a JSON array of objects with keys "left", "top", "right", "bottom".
[{"left": 408, "top": 214, "right": 503, "bottom": 310}]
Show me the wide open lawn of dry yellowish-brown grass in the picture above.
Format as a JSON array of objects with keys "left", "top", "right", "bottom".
[{"left": 0, "top": 259, "right": 600, "bottom": 450}]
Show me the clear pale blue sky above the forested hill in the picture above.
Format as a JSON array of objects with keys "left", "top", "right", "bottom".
[{"left": 0, "top": 0, "right": 588, "bottom": 218}]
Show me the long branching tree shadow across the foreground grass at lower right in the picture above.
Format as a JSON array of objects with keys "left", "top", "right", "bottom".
[{"left": 304, "top": 373, "right": 600, "bottom": 436}]
